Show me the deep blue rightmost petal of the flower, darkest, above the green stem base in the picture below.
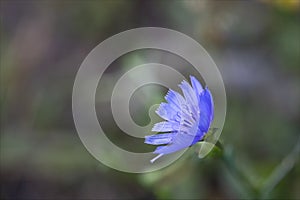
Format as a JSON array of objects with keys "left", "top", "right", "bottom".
[{"left": 199, "top": 88, "right": 214, "bottom": 133}]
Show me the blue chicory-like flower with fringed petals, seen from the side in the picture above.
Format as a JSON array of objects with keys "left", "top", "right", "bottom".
[{"left": 145, "top": 76, "right": 214, "bottom": 163}]
